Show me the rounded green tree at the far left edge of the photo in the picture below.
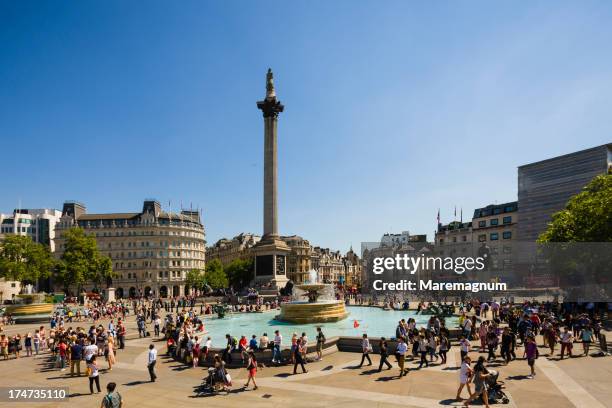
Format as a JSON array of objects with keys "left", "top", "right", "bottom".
[{"left": 0, "top": 235, "right": 55, "bottom": 285}]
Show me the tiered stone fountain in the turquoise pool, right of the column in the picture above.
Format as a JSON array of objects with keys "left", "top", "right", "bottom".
[{"left": 276, "top": 270, "right": 348, "bottom": 324}]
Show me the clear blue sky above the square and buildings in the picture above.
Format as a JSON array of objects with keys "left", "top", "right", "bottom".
[{"left": 0, "top": 0, "right": 612, "bottom": 251}]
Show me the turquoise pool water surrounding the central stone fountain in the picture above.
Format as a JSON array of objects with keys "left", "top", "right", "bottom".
[{"left": 204, "top": 306, "right": 458, "bottom": 348}]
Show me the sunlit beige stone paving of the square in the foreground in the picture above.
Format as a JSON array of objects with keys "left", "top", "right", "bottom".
[{"left": 0, "top": 324, "right": 612, "bottom": 408}]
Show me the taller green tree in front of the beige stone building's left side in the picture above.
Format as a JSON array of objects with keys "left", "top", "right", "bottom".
[{"left": 56, "top": 227, "right": 115, "bottom": 291}]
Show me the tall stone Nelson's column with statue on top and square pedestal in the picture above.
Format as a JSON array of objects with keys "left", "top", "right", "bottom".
[{"left": 253, "top": 69, "right": 290, "bottom": 290}]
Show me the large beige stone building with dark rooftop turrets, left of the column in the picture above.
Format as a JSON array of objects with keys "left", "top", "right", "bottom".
[{"left": 55, "top": 200, "right": 206, "bottom": 298}]
